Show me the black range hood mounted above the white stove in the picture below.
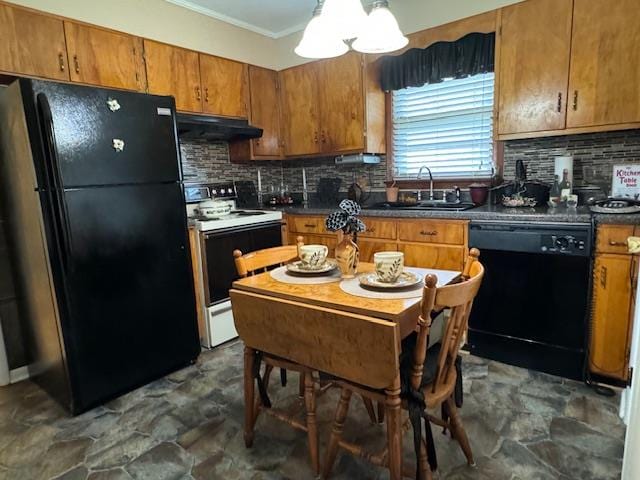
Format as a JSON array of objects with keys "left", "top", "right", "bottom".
[{"left": 176, "top": 113, "right": 262, "bottom": 141}]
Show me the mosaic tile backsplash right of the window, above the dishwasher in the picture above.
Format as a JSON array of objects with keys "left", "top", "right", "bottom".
[{"left": 504, "top": 130, "right": 640, "bottom": 189}]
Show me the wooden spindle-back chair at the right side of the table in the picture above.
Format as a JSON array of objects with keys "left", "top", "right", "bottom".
[{"left": 323, "top": 249, "right": 484, "bottom": 480}]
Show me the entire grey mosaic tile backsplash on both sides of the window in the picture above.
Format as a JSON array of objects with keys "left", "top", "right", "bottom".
[{"left": 180, "top": 130, "right": 640, "bottom": 198}]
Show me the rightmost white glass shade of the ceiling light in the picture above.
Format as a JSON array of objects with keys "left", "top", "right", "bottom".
[{"left": 351, "top": 5, "right": 409, "bottom": 53}]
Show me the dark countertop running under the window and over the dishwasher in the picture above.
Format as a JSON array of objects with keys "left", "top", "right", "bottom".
[{"left": 262, "top": 204, "right": 640, "bottom": 225}]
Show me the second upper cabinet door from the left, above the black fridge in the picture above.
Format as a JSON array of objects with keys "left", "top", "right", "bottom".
[{"left": 64, "top": 22, "right": 146, "bottom": 91}]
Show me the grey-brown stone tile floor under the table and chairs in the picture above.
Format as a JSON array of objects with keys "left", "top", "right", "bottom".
[{"left": 0, "top": 342, "right": 625, "bottom": 480}]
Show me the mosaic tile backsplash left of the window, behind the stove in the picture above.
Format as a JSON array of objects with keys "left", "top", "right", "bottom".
[{"left": 180, "top": 140, "right": 387, "bottom": 192}]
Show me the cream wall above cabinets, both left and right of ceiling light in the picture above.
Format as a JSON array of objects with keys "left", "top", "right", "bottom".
[{"left": 10, "top": 0, "right": 521, "bottom": 70}]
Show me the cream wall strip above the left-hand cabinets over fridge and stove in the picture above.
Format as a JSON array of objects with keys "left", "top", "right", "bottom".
[{"left": 9, "top": 0, "right": 280, "bottom": 68}]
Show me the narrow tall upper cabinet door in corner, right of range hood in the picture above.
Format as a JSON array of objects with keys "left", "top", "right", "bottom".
[{"left": 249, "top": 65, "right": 282, "bottom": 157}]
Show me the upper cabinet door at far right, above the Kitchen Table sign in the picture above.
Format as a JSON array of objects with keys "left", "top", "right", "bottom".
[{"left": 567, "top": 0, "right": 640, "bottom": 127}]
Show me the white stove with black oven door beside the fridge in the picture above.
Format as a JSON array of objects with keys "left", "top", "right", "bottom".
[{"left": 185, "top": 184, "right": 282, "bottom": 348}]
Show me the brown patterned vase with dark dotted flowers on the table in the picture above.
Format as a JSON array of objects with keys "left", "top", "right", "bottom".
[{"left": 325, "top": 200, "right": 366, "bottom": 278}]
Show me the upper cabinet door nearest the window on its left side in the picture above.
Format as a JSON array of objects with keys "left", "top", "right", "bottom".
[{"left": 318, "top": 52, "right": 365, "bottom": 153}]
